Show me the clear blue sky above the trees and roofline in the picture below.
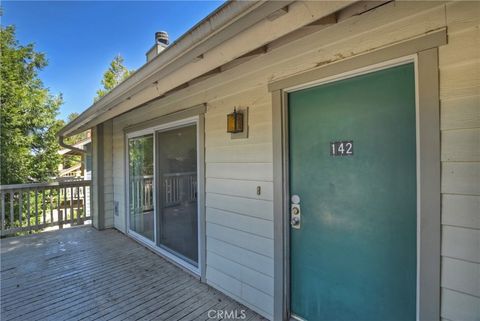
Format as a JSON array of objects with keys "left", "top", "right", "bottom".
[{"left": 1, "top": 1, "right": 223, "bottom": 119}]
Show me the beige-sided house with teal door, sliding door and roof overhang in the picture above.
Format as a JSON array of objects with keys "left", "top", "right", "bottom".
[{"left": 60, "top": 1, "right": 480, "bottom": 321}]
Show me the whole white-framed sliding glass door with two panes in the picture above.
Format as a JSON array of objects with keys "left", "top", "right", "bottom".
[{"left": 127, "top": 118, "right": 199, "bottom": 271}]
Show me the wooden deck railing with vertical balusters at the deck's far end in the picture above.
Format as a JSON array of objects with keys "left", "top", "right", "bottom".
[{"left": 0, "top": 180, "right": 91, "bottom": 236}]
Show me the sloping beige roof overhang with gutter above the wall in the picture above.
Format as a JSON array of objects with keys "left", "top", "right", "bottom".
[{"left": 58, "top": 0, "right": 355, "bottom": 138}]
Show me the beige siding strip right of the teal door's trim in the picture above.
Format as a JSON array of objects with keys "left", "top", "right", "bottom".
[{"left": 439, "top": 2, "right": 480, "bottom": 321}]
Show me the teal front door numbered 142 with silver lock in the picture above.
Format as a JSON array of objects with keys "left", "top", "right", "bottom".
[{"left": 288, "top": 64, "right": 417, "bottom": 321}]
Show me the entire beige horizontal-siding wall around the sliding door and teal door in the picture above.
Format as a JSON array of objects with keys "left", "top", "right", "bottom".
[{"left": 106, "top": 1, "right": 480, "bottom": 321}]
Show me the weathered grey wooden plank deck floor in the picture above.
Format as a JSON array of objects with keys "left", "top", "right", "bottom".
[{"left": 0, "top": 227, "right": 264, "bottom": 321}]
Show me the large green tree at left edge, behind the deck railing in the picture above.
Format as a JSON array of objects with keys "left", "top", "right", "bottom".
[{"left": 0, "top": 26, "right": 63, "bottom": 184}]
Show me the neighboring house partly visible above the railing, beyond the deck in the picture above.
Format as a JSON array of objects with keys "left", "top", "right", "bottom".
[{"left": 58, "top": 131, "right": 92, "bottom": 179}]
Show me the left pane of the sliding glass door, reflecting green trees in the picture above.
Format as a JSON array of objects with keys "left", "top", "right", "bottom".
[{"left": 128, "top": 135, "right": 154, "bottom": 241}]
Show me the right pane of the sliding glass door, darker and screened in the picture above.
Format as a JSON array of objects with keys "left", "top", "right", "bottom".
[{"left": 156, "top": 125, "right": 198, "bottom": 265}]
